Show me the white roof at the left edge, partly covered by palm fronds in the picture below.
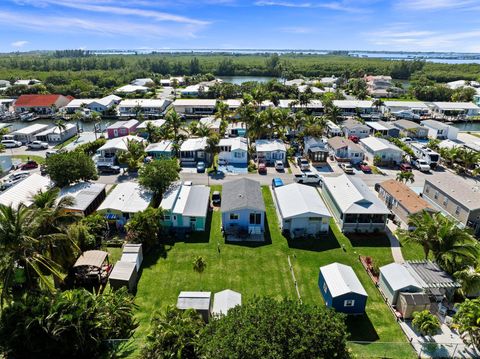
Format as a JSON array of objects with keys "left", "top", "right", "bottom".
[{"left": 0, "top": 173, "right": 53, "bottom": 208}]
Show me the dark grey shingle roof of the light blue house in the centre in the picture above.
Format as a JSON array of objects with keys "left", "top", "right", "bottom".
[{"left": 221, "top": 178, "right": 265, "bottom": 212}]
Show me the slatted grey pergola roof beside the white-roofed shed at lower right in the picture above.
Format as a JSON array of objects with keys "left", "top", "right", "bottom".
[{"left": 405, "top": 260, "right": 460, "bottom": 289}]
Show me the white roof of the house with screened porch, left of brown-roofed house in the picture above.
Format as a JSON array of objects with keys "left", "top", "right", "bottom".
[{"left": 323, "top": 174, "right": 390, "bottom": 214}]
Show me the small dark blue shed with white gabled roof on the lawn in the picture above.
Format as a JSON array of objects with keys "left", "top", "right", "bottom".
[{"left": 318, "top": 263, "right": 368, "bottom": 314}]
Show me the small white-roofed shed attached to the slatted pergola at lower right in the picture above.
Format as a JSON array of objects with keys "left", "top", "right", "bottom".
[{"left": 378, "top": 263, "right": 423, "bottom": 305}]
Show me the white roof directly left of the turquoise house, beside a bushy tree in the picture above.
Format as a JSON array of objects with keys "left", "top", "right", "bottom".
[{"left": 98, "top": 182, "right": 153, "bottom": 213}]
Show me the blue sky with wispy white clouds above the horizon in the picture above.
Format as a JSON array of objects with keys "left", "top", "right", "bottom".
[{"left": 0, "top": 0, "right": 480, "bottom": 52}]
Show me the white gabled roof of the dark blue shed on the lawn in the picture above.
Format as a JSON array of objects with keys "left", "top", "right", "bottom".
[{"left": 320, "top": 262, "right": 368, "bottom": 298}]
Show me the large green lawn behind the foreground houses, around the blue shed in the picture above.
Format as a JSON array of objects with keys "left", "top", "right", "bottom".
[{"left": 129, "top": 186, "right": 414, "bottom": 358}]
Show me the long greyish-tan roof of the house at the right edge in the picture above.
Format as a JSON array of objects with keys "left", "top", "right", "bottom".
[{"left": 424, "top": 171, "right": 480, "bottom": 211}]
